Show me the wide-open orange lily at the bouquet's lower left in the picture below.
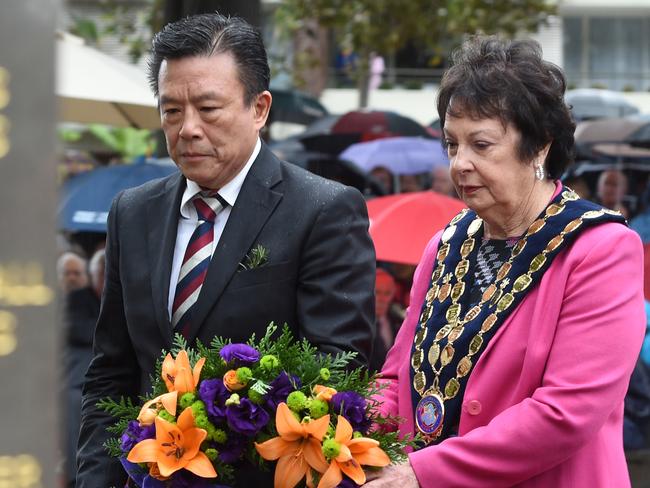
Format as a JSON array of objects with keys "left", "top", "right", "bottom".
[{"left": 127, "top": 408, "right": 217, "bottom": 478}]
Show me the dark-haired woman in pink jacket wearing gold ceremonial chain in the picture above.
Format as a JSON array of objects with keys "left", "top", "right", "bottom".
[{"left": 365, "top": 37, "right": 645, "bottom": 488}]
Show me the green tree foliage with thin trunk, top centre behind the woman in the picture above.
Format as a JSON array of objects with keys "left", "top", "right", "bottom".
[{"left": 277, "top": 0, "right": 556, "bottom": 106}]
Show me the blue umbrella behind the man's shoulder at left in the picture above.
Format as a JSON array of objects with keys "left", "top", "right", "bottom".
[{"left": 58, "top": 159, "right": 176, "bottom": 232}]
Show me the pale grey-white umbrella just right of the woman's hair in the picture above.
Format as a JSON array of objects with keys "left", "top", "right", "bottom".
[{"left": 564, "top": 88, "right": 639, "bottom": 120}]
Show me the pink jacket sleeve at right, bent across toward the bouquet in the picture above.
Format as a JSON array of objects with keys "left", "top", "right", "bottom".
[{"left": 408, "top": 224, "right": 645, "bottom": 488}]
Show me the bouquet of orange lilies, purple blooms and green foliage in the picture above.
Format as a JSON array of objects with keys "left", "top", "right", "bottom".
[{"left": 98, "top": 323, "right": 414, "bottom": 488}]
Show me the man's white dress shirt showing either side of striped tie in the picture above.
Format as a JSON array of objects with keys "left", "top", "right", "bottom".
[{"left": 167, "top": 138, "right": 262, "bottom": 320}]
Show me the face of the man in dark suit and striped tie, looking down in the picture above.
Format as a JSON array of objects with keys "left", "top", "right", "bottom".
[{"left": 158, "top": 53, "right": 271, "bottom": 190}]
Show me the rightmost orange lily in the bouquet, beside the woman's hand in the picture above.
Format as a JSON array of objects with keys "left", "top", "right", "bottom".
[{"left": 318, "top": 415, "right": 390, "bottom": 488}]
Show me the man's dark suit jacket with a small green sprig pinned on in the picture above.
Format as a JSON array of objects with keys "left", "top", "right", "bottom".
[{"left": 77, "top": 145, "right": 375, "bottom": 488}]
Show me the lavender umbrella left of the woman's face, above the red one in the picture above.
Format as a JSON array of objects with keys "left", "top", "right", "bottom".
[{"left": 339, "top": 137, "right": 449, "bottom": 175}]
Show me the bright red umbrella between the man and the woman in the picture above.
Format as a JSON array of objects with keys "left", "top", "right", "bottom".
[{"left": 368, "top": 191, "right": 465, "bottom": 264}]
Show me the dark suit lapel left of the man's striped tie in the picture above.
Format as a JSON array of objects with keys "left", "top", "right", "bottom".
[{"left": 147, "top": 172, "right": 185, "bottom": 349}]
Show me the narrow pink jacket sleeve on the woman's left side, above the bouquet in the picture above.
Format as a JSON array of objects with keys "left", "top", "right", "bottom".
[{"left": 376, "top": 232, "right": 442, "bottom": 415}]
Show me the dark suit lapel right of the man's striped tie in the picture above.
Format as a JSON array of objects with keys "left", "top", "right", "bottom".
[{"left": 188, "top": 144, "right": 282, "bottom": 342}]
